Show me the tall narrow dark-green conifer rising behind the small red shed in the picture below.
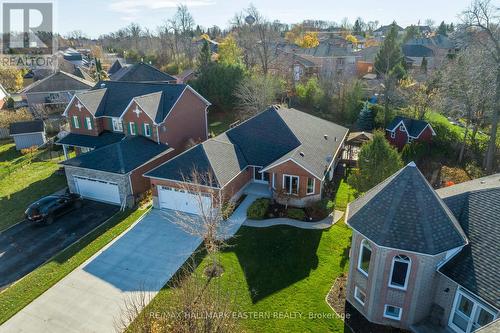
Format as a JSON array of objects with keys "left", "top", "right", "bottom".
[{"left": 374, "top": 22, "right": 406, "bottom": 125}]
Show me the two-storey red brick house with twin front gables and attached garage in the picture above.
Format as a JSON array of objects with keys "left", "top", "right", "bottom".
[{"left": 57, "top": 81, "right": 210, "bottom": 205}]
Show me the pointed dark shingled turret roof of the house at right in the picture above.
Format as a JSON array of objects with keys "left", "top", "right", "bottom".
[{"left": 346, "top": 162, "right": 467, "bottom": 255}]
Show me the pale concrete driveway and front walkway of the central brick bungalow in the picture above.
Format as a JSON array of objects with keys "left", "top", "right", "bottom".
[{"left": 0, "top": 196, "right": 255, "bottom": 333}]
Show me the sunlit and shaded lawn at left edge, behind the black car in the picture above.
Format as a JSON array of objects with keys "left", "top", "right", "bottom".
[{"left": 0, "top": 141, "right": 66, "bottom": 230}]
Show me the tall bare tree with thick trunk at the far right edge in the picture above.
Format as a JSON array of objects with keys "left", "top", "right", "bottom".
[{"left": 462, "top": 0, "right": 500, "bottom": 174}]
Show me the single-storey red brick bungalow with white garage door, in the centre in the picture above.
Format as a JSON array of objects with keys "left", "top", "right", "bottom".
[{"left": 145, "top": 107, "right": 348, "bottom": 213}]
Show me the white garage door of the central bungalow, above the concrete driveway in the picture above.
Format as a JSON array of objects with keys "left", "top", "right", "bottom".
[{"left": 158, "top": 186, "right": 211, "bottom": 214}]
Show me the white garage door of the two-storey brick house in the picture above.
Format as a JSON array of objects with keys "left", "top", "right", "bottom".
[{"left": 74, "top": 176, "right": 120, "bottom": 205}]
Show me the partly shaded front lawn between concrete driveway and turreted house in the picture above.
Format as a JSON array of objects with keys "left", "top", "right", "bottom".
[{"left": 138, "top": 222, "right": 351, "bottom": 332}]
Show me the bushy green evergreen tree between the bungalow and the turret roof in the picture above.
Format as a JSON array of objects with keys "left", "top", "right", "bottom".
[{"left": 347, "top": 131, "right": 403, "bottom": 193}]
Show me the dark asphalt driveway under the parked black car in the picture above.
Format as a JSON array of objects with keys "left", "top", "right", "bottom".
[{"left": 0, "top": 200, "right": 119, "bottom": 290}]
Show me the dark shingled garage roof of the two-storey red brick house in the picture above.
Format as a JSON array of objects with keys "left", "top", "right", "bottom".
[{"left": 62, "top": 136, "right": 171, "bottom": 174}]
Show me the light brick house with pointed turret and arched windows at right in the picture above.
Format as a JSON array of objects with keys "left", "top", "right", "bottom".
[{"left": 346, "top": 162, "right": 500, "bottom": 333}]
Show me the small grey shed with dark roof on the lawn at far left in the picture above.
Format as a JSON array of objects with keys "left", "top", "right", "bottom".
[{"left": 9, "top": 120, "right": 47, "bottom": 150}]
